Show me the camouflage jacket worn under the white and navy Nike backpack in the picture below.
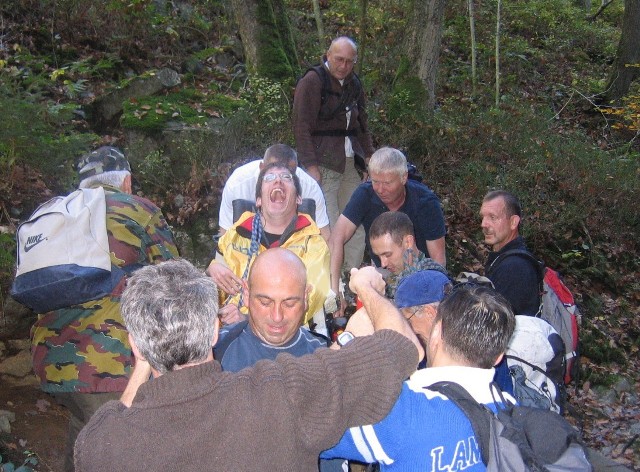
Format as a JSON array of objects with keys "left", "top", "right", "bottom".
[{"left": 31, "top": 187, "right": 178, "bottom": 393}]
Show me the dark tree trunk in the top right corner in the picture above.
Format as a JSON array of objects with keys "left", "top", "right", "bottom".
[{"left": 605, "top": 0, "right": 640, "bottom": 102}]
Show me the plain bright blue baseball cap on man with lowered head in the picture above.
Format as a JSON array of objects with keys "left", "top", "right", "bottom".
[{"left": 395, "top": 270, "right": 451, "bottom": 308}]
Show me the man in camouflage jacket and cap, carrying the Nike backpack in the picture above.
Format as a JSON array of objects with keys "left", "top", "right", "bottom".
[{"left": 31, "top": 146, "right": 178, "bottom": 471}]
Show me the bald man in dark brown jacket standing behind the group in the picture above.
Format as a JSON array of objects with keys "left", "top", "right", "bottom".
[{"left": 293, "top": 36, "right": 373, "bottom": 267}]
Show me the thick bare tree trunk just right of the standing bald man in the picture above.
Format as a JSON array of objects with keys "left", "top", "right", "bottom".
[{"left": 406, "top": 0, "right": 446, "bottom": 110}]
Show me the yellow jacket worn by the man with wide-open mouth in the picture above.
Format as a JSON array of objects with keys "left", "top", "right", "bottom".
[{"left": 218, "top": 211, "right": 330, "bottom": 323}]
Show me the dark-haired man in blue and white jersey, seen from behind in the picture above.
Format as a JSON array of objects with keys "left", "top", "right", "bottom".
[{"left": 321, "top": 285, "right": 515, "bottom": 471}]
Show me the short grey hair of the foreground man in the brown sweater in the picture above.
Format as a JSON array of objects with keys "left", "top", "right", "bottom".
[{"left": 121, "top": 259, "right": 218, "bottom": 374}]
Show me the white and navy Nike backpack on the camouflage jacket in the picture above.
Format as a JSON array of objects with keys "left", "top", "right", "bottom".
[{"left": 11, "top": 187, "right": 124, "bottom": 313}]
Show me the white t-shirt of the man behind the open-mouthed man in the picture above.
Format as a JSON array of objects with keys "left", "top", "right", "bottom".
[{"left": 218, "top": 159, "right": 329, "bottom": 230}]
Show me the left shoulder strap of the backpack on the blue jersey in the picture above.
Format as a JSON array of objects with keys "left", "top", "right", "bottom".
[{"left": 425, "top": 382, "right": 493, "bottom": 466}]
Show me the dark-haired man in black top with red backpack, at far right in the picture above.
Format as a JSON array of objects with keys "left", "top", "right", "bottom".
[{"left": 480, "top": 190, "right": 541, "bottom": 316}]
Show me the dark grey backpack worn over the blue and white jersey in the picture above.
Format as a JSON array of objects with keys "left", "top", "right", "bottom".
[{"left": 425, "top": 382, "right": 592, "bottom": 472}]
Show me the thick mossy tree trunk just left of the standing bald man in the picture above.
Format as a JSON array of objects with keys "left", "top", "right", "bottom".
[{"left": 231, "top": 0, "right": 299, "bottom": 82}]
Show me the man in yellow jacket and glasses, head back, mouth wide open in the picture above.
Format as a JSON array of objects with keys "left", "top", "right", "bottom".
[{"left": 207, "top": 163, "right": 329, "bottom": 334}]
